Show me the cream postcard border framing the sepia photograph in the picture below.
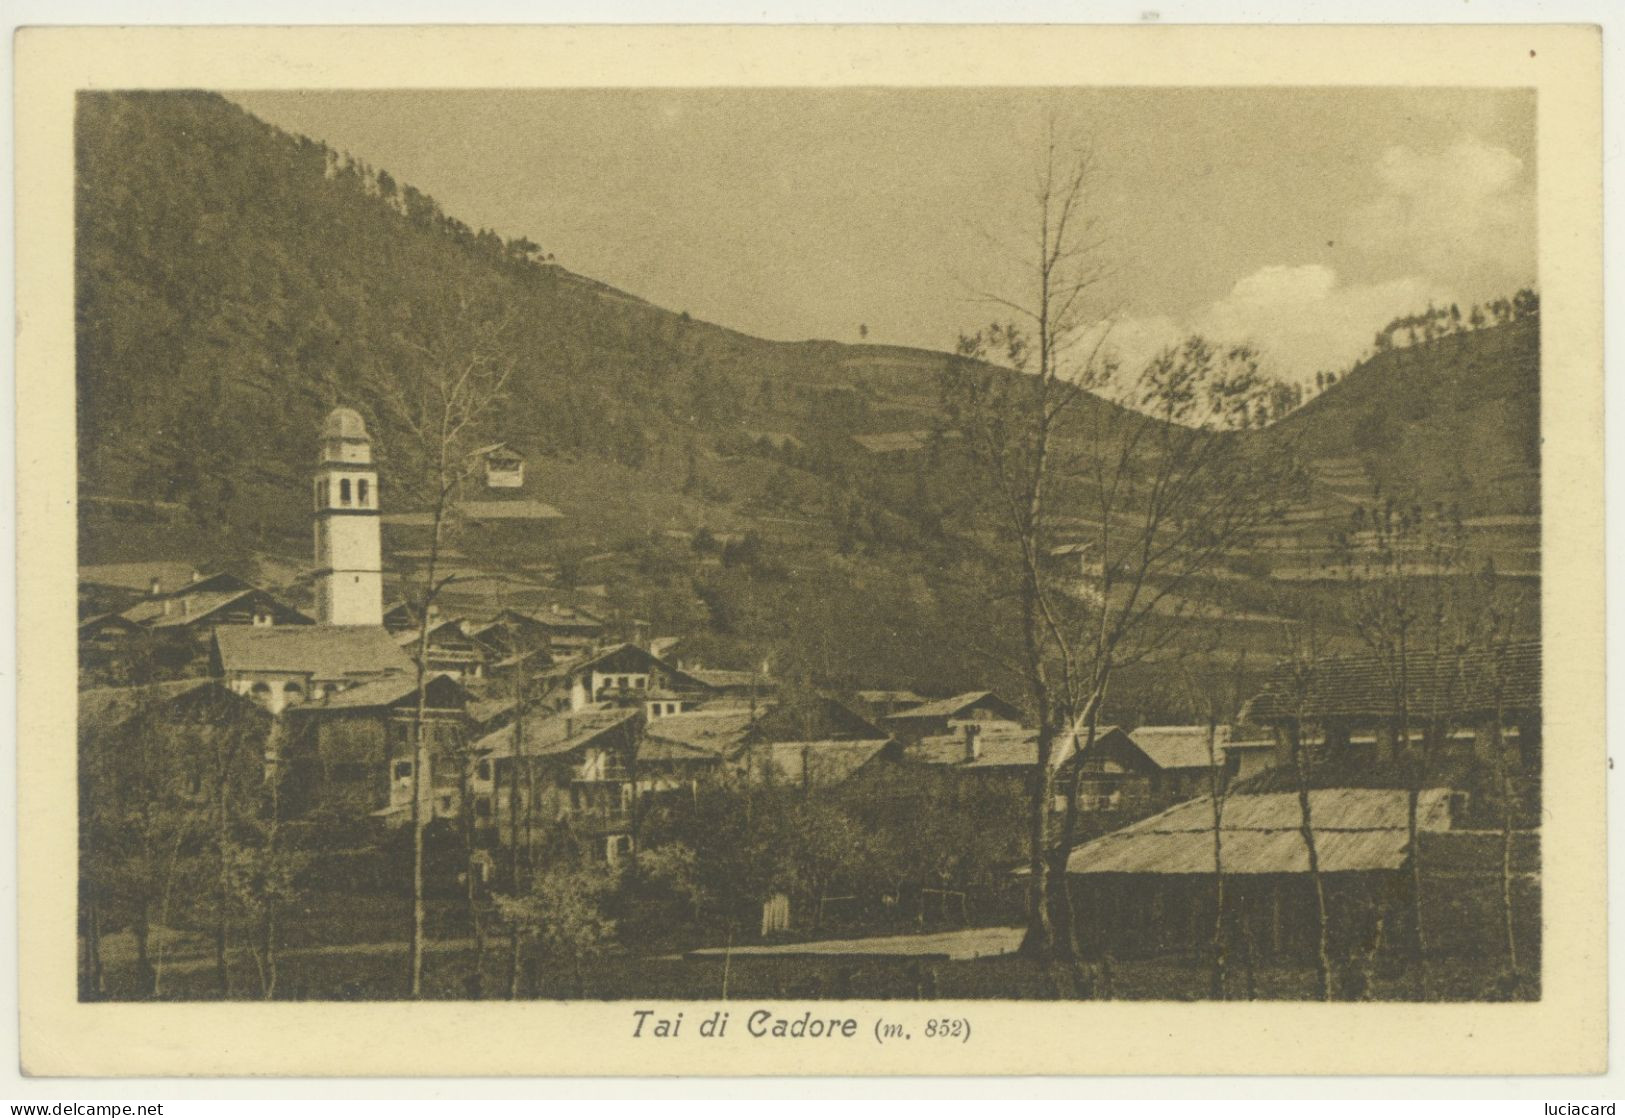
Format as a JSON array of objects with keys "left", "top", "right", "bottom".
[{"left": 15, "top": 26, "right": 1607, "bottom": 1076}]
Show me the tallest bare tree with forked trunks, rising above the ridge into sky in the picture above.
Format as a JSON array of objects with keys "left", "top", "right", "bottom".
[{"left": 943, "top": 137, "right": 1294, "bottom": 960}]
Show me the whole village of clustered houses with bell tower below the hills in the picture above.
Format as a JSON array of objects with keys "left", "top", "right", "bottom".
[{"left": 80, "top": 406, "right": 1542, "bottom": 998}]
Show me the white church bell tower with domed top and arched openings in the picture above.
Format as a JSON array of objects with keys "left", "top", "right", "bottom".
[{"left": 315, "top": 408, "right": 384, "bottom": 626}]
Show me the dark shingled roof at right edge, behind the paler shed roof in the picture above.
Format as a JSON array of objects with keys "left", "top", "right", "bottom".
[{"left": 1243, "top": 640, "right": 1541, "bottom": 723}]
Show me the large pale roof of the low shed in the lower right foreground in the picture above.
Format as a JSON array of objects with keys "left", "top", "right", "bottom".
[{"left": 1066, "top": 788, "right": 1450, "bottom": 874}]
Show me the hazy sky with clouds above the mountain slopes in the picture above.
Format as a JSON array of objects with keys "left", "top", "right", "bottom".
[{"left": 229, "top": 88, "right": 1536, "bottom": 379}]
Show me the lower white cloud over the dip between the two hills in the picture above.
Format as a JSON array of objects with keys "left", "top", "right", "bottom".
[{"left": 1095, "top": 263, "right": 1454, "bottom": 380}]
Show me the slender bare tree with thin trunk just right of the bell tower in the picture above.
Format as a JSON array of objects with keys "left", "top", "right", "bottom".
[{"left": 379, "top": 287, "right": 515, "bottom": 998}]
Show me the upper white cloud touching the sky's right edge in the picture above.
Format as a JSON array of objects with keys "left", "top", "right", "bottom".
[{"left": 1346, "top": 135, "right": 1534, "bottom": 283}]
